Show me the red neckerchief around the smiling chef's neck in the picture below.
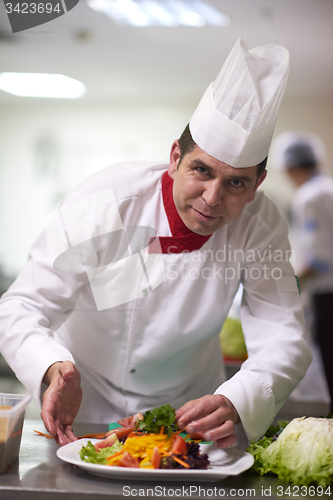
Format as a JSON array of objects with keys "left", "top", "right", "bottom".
[{"left": 149, "top": 172, "right": 211, "bottom": 253}]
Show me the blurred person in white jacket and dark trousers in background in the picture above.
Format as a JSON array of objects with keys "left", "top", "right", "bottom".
[{"left": 274, "top": 130, "right": 333, "bottom": 412}]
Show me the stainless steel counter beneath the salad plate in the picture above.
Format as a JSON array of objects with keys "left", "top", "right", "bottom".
[{"left": 0, "top": 420, "right": 333, "bottom": 500}]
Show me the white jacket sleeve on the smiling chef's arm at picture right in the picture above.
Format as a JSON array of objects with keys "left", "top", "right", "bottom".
[{"left": 216, "top": 194, "right": 312, "bottom": 441}]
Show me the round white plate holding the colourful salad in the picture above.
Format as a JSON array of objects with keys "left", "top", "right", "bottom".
[{"left": 57, "top": 438, "right": 254, "bottom": 482}]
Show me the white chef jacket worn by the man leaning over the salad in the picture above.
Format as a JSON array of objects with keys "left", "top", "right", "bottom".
[{"left": 0, "top": 162, "right": 311, "bottom": 440}]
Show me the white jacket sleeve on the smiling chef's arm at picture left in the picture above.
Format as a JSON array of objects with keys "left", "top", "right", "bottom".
[{"left": 0, "top": 174, "right": 126, "bottom": 402}]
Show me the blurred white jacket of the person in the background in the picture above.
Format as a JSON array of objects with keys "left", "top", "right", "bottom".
[{"left": 292, "top": 173, "right": 333, "bottom": 293}]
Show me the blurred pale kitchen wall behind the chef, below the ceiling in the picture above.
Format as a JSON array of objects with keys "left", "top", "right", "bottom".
[{"left": 0, "top": 93, "right": 333, "bottom": 276}]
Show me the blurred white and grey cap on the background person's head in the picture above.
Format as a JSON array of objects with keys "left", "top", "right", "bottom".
[{"left": 272, "top": 130, "right": 326, "bottom": 170}]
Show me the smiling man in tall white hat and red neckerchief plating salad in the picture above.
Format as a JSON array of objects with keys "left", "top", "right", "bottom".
[{"left": 0, "top": 39, "right": 311, "bottom": 447}]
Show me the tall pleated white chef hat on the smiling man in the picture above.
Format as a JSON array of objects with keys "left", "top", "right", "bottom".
[{"left": 190, "top": 38, "right": 289, "bottom": 168}]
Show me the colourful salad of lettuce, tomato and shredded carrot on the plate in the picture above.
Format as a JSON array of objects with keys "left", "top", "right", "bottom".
[{"left": 80, "top": 404, "right": 209, "bottom": 469}]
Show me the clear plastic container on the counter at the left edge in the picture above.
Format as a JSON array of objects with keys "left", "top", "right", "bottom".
[{"left": 0, "top": 393, "right": 32, "bottom": 474}]
